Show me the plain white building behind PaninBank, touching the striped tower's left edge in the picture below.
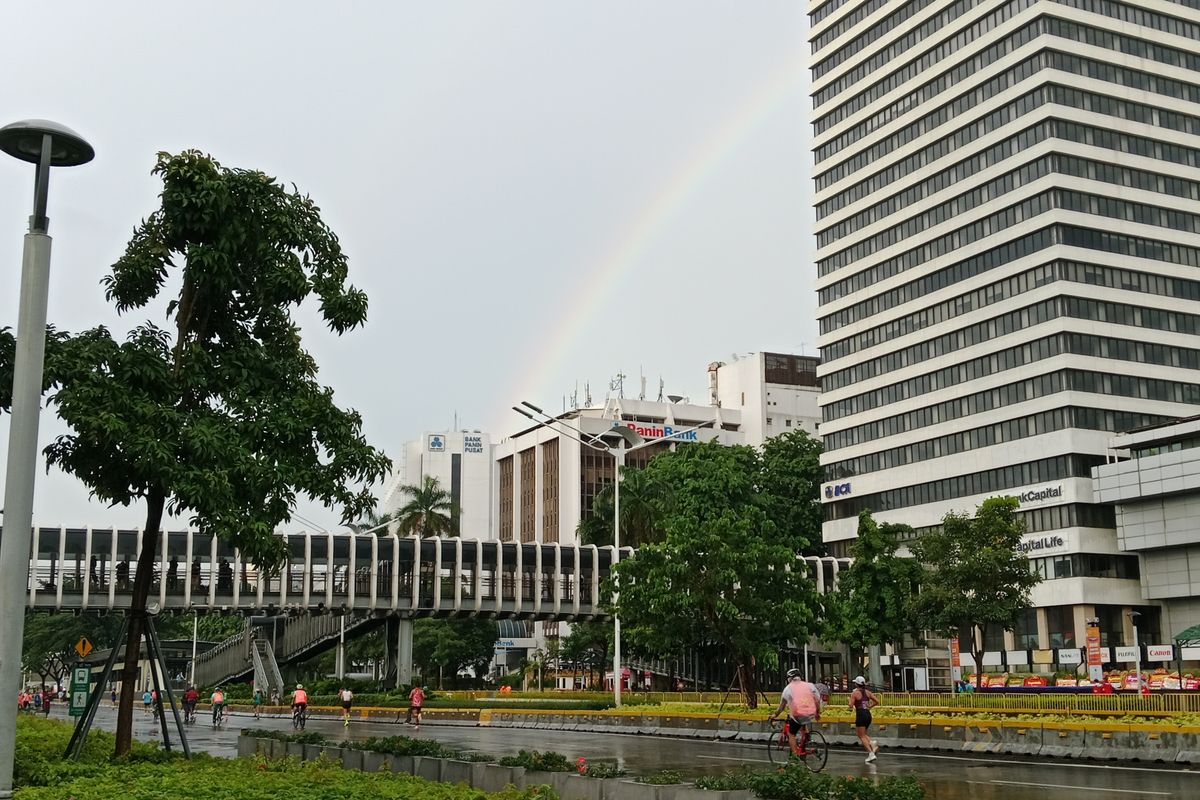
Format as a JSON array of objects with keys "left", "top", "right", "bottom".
[{"left": 708, "top": 353, "right": 821, "bottom": 446}]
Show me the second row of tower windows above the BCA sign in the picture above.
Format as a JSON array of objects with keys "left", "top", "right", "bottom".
[{"left": 822, "top": 369, "right": 1200, "bottom": 452}]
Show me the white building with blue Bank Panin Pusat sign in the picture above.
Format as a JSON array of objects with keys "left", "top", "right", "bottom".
[{"left": 383, "top": 431, "right": 493, "bottom": 540}]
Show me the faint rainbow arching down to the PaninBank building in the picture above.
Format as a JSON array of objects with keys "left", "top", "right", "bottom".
[{"left": 502, "top": 54, "right": 808, "bottom": 417}]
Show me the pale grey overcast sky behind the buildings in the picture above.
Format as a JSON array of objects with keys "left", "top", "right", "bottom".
[{"left": 0, "top": 0, "right": 816, "bottom": 528}]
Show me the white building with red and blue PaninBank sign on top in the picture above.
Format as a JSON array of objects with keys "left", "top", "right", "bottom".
[{"left": 493, "top": 398, "right": 745, "bottom": 543}]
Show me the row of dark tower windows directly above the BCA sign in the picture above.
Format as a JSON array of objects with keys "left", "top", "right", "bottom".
[{"left": 824, "top": 407, "right": 1174, "bottom": 481}]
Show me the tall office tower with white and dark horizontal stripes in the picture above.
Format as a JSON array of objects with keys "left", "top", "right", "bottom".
[{"left": 810, "top": 0, "right": 1200, "bottom": 668}]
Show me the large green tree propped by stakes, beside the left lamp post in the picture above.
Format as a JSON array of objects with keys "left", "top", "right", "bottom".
[{"left": 0, "top": 151, "right": 389, "bottom": 754}]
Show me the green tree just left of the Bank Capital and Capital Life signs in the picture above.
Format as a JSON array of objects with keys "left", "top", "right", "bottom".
[{"left": 911, "top": 497, "right": 1042, "bottom": 681}]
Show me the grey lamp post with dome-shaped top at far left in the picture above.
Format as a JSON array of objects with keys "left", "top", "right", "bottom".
[{"left": 0, "top": 120, "right": 96, "bottom": 799}]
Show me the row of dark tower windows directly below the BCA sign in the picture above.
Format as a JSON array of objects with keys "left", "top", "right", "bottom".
[{"left": 824, "top": 455, "right": 1104, "bottom": 521}]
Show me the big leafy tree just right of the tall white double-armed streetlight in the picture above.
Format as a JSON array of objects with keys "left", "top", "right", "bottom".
[{"left": 610, "top": 441, "right": 818, "bottom": 708}]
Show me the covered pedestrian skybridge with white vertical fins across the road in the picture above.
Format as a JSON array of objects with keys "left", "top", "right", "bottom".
[{"left": 16, "top": 528, "right": 630, "bottom": 620}]
